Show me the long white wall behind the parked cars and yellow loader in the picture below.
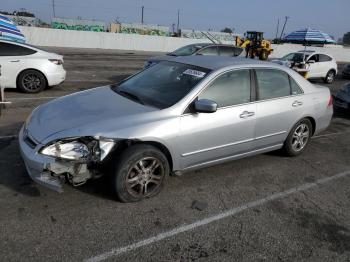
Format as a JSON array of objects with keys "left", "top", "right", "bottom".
[{"left": 18, "top": 26, "right": 350, "bottom": 62}]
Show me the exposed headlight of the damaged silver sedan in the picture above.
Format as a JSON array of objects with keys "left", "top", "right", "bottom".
[{"left": 40, "top": 141, "right": 90, "bottom": 160}]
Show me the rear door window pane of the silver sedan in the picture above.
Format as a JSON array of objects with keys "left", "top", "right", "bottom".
[{"left": 255, "top": 69, "right": 290, "bottom": 100}]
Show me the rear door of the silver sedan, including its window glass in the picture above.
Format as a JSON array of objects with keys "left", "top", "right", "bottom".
[{"left": 254, "top": 69, "right": 304, "bottom": 150}]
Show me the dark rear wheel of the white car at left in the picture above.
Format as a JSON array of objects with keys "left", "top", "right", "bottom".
[{"left": 17, "top": 70, "right": 47, "bottom": 94}]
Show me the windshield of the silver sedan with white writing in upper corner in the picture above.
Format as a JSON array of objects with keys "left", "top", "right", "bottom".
[{"left": 112, "top": 61, "right": 210, "bottom": 109}]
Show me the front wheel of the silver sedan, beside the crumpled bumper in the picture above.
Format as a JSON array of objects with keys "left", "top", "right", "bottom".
[{"left": 112, "top": 145, "right": 170, "bottom": 203}]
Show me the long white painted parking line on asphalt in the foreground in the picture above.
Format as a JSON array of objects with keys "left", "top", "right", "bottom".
[{"left": 85, "top": 170, "right": 350, "bottom": 262}]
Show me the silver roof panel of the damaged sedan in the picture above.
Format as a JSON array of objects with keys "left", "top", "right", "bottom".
[{"left": 164, "top": 56, "right": 283, "bottom": 70}]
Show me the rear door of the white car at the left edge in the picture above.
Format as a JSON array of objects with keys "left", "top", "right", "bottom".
[{"left": 0, "top": 42, "right": 36, "bottom": 88}]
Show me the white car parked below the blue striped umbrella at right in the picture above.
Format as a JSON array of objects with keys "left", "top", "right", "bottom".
[{"left": 272, "top": 50, "right": 338, "bottom": 84}]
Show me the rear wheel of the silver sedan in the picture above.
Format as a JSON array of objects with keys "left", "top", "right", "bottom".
[{"left": 282, "top": 119, "right": 312, "bottom": 156}]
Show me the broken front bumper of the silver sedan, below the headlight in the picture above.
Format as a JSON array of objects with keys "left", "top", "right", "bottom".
[{"left": 19, "top": 126, "right": 99, "bottom": 192}]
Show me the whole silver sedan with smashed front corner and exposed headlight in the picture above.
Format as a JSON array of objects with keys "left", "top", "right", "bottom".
[{"left": 19, "top": 56, "right": 333, "bottom": 202}]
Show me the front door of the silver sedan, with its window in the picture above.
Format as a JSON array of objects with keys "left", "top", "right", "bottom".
[{"left": 179, "top": 69, "right": 256, "bottom": 169}]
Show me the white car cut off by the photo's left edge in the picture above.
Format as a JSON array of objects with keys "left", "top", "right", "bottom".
[{"left": 0, "top": 40, "right": 66, "bottom": 93}]
